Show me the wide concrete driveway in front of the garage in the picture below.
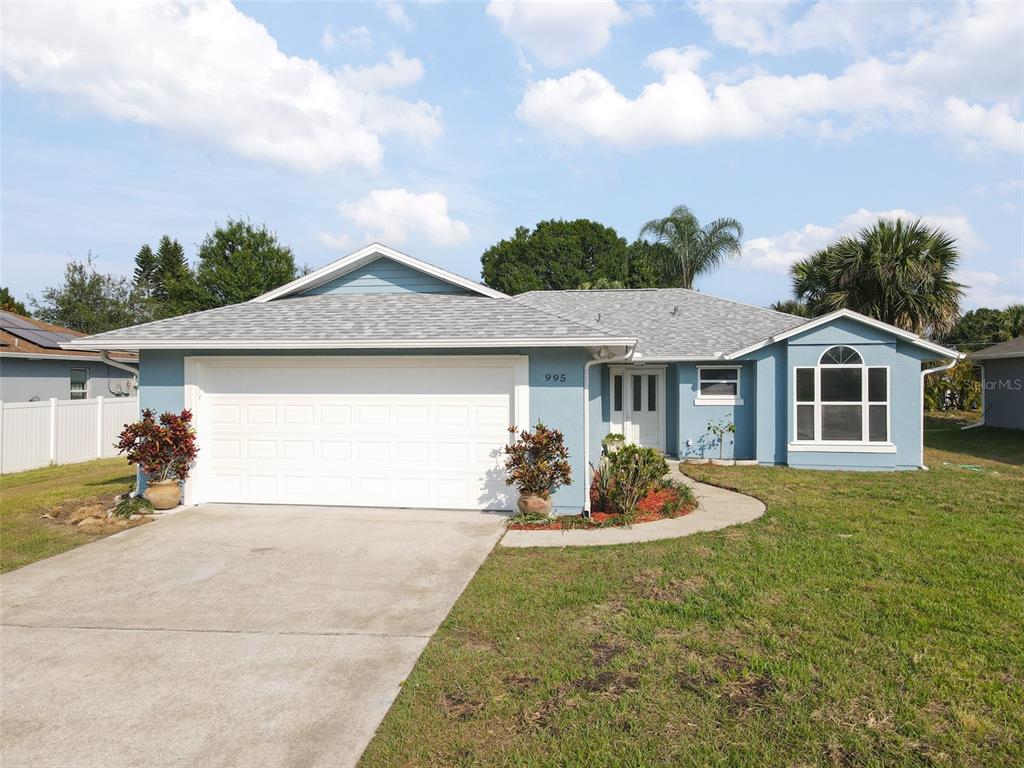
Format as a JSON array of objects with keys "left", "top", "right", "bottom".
[{"left": 0, "top": 505, "right": 502, "bottom": 768}]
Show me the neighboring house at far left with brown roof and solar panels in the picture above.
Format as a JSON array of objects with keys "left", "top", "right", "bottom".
[{"left": 0, "top": 311, "right": 138, "bottom": 402}]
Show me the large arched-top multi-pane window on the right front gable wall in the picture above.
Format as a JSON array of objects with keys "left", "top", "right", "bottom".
[{"left": 794, "top": 346, "right": 889, "bottom": 443}]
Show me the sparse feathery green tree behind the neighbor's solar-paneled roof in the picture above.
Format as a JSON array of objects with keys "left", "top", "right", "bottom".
[{"left": 29, "top": 252, "right": 144, "bottom": 334}]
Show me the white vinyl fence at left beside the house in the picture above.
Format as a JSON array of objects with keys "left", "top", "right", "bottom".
[{"left": 0, "top": 397, "right": 138, "bottom": 473}]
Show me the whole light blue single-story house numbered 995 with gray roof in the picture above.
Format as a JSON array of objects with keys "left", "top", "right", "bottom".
[{"left": 68, "top": 244, "right": 963, "bottom": 512}]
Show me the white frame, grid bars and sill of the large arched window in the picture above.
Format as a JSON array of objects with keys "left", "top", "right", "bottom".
[{"left": 790, "top": 344, "right": 896, "bottom": 454}]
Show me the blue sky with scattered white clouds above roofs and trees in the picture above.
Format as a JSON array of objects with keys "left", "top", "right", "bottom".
[{"left": 0, "top": 2, "right": 1024, "bottom": 307}]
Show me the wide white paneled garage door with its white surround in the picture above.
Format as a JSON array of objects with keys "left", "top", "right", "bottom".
[{"left": 186, "top": 356, "right": 528, "bottom": 509}]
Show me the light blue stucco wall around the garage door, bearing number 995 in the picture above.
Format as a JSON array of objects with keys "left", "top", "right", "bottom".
[{"left": 139, "top": 348, "right": 590, "bottom": 514}]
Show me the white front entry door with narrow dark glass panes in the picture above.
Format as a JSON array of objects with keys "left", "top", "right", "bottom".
[{"left": 611, "top": 367, "right": 665, "bottom": 451}]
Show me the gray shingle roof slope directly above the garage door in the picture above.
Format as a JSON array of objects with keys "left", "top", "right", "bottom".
[{"left": 64, "top": 293, "right": 635, "bottom": 349}]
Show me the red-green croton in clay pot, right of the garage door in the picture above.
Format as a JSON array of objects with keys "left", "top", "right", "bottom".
[{"left": 505, "top": 422, "right": 572, "bottom": 518}]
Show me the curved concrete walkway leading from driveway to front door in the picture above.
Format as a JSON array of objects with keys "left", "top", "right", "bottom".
[{"left": 501, "top": 468, "right": 765, "bottom": 547}]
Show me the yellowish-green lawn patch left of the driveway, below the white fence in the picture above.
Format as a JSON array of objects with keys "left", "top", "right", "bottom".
[{"left": 0, "top": 459, "right": 135, "bottom": 572}]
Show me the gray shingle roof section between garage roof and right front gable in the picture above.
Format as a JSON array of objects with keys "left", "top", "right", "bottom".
[{"left": 515, "top": 288, "right": 807, "bottom": 359}]
